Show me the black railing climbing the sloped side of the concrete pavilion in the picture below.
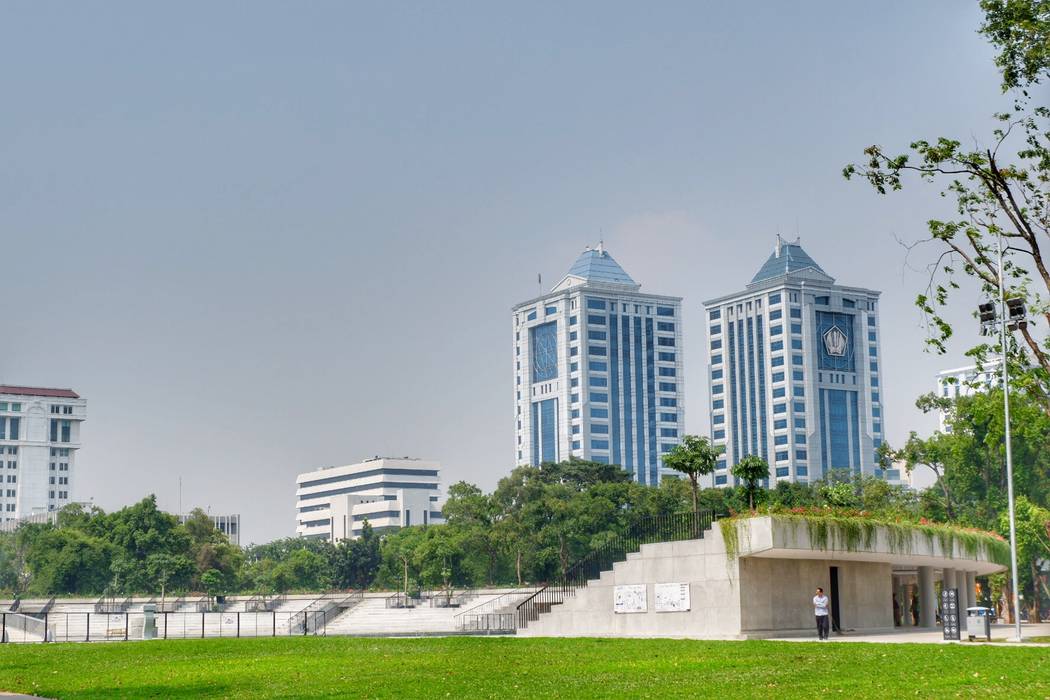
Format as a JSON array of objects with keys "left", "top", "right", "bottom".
[{"left": 517, "top": 510, "right": 714, "bottom": 630}]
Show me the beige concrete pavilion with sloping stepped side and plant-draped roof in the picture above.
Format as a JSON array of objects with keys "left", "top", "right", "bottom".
[{"left": 519, "top": 516, "right": 1005, "bottom": 639}]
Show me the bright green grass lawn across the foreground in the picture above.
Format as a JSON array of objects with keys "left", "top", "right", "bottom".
[{"left": 0, "top": 637, "right": 1050, "bottom": 700}]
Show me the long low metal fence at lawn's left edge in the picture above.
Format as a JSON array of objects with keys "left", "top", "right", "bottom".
[{"left": 0, "top": 609, "right": 342, "bottom": 643}]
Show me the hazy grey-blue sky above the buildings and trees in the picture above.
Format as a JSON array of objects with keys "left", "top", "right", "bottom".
[{"left": 0, "top": 0, "right": 1009, "bottom": 543}]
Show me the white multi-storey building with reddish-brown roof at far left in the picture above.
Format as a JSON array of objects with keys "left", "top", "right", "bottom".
[{"left": 0, "top": 384, "right": 87, "bottom": 523}]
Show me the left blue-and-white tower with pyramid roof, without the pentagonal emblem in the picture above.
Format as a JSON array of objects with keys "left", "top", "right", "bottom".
[{"left": 512, "top": 243, "right": 685, "bottom": 484}]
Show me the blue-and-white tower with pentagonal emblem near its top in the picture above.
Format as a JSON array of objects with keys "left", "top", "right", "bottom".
[{"left": 705, "top": 236, "right": 883, "bottom": 486}]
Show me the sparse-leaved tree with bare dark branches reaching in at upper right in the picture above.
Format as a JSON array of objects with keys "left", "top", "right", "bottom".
[{"left": 843, "top": 0, "right": 1050, "bottom": 413}]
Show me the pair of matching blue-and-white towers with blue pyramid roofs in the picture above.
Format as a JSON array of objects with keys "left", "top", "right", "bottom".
[{"left": 513, "top": 236, "right": 884, "bottom": 486}]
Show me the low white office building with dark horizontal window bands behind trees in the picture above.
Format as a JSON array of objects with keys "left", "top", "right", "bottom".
[{"left": 295, "top": 457, "right": 445, "bottom": 542}]
